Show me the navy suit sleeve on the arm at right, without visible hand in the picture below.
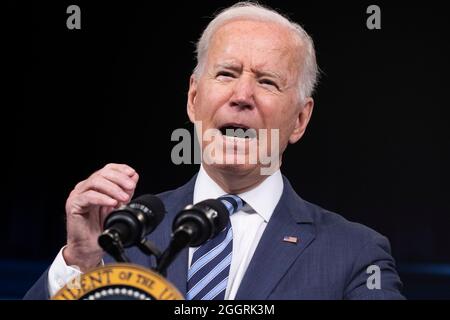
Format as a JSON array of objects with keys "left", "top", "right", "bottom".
[{"left": 344, "top": 234, "right": 405, "bottom": 300}]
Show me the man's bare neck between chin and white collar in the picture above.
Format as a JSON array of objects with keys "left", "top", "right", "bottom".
[{"left": 203, "top": 163, "right": 269, "bottom": 194}]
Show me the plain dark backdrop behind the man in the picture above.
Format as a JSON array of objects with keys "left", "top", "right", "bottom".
[{"left": 4, "top": 1, "right": 450, "bottom": 298}]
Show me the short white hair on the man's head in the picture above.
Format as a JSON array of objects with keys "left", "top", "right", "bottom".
[{"left": 194, "top": 2, "right": 319, "bottom": 101}]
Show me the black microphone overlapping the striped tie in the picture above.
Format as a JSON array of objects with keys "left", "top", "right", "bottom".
[{"left": 156, "top": 199, "right": 230, "bottom": 274}]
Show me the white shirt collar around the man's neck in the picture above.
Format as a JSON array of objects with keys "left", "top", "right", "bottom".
[{"left": 194, "top": 166, "right": 283, "bottom": 222}]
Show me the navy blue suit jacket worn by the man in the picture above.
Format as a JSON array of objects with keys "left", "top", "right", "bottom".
[{"left": 25, "top": 177, "right": 403, "bottom": 300}]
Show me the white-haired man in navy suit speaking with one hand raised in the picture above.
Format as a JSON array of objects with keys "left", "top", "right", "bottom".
[{"left": 26, "top": 3, "right": 403, "bottom": 299}]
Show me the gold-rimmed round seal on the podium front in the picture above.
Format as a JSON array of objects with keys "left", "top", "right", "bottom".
[{"left": 52, "top": 263, "right": 183, "bottom": 300}]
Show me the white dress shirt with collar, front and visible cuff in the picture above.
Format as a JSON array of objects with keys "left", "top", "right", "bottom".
[{"left": 48, "top": 166, "right": 283, "bottom": 300}]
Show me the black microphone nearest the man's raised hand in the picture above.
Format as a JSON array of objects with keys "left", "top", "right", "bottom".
[{"left": 98, "top": 194, "right": 166, "bottom": 261}]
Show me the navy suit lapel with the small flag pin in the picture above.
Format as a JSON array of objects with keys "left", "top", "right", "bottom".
[{"left": 236, "top": 177, "right": 315, "bottom": 300}]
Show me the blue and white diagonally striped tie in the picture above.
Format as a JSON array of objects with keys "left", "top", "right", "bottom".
[{"left": 186, "top": 195, "right": 245, "bottom": 300}]
